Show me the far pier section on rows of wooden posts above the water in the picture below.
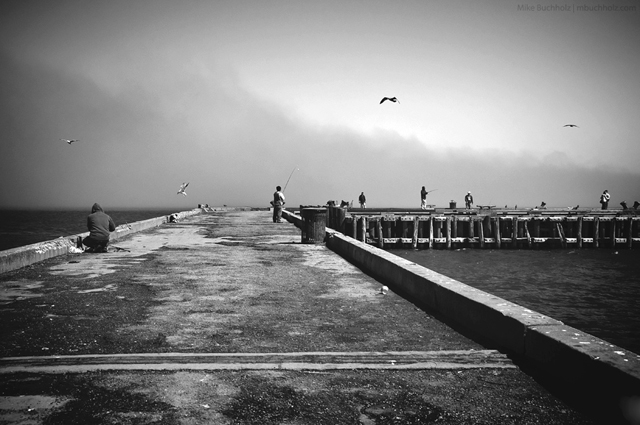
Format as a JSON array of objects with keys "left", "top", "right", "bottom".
[{"left": 327, "top": 207, "right": 640, "bottom": 249}]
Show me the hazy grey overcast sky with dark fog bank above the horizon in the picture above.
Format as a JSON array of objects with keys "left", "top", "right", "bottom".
[{"left": 0, "top": 0, "right": 640, "bottom": 210}]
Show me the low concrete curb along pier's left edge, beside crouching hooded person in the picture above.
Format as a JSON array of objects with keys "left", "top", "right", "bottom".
[{"left": 0, "top": 208, "right": 203, "bottom": 273}]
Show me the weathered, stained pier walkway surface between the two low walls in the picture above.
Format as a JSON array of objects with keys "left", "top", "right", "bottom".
[{"left": 0, "top": 211, "right": 616, "bottom": 424}]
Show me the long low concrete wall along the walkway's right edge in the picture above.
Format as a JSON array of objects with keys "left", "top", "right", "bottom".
[{"left": 326, "top": 225, "right": 640, "bottom": 400}]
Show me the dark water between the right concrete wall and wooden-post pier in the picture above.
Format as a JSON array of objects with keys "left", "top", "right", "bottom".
[{"left": 390, "top": 249, "right": 640, "bottom": 353}]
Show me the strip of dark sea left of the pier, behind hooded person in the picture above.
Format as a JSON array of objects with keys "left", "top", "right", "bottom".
[{"left": 0, "top": 208, "right": 179, "bottom": 251}]
